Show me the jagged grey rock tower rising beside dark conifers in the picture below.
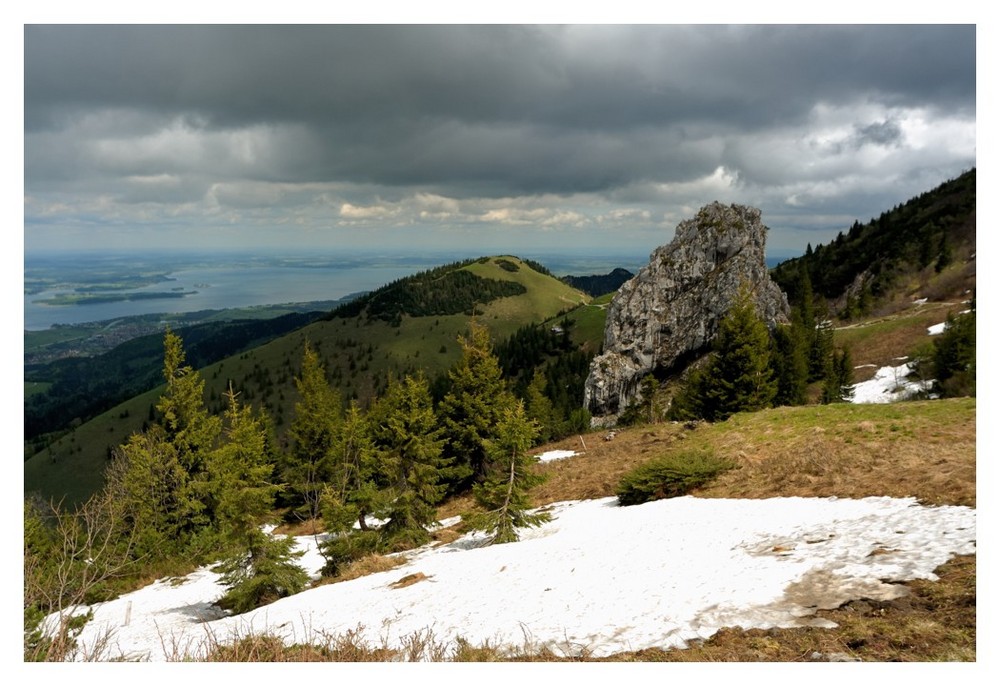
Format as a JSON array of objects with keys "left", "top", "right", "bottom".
[{"left": 584, "top": 202, "right": 789, "bottom": 417}]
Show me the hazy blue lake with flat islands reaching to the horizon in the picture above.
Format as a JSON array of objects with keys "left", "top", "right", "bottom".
[{"left": 24, "top": 252, "right": 648, "bottom": 331}]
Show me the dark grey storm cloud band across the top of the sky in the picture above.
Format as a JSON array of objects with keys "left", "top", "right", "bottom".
[{"left": 25, "top": 26, "right": 975, "bottom": 194}]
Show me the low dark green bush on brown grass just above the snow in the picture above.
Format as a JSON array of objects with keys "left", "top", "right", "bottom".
[{"left": 617, "top": 451, "right": 736, "bottom": 505}]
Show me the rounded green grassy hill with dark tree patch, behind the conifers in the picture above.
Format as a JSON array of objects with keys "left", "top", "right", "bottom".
[{"left": 24, "top": 256, "right": 603, "bottom": 502}]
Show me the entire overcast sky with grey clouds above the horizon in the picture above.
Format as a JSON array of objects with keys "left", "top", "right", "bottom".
[{"left": 24, "top": 25, "right": 976, "bottom": 254}]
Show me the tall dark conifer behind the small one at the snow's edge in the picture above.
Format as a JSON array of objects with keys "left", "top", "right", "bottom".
[{"left": 438, "top": 322, "right": 514, "bottom": 490}]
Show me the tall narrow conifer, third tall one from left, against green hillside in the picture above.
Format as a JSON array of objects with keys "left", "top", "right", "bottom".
[{"left": 281, "top": 343, "right": 341, "bottom": 519}]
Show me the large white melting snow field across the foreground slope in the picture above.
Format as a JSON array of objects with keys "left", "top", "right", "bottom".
[{"left": 48, "top": 497, "right": 976, "bottom": 661}]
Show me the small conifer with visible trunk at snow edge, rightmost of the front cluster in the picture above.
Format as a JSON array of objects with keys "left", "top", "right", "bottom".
[{"left": 463, "top": 401, "right": 550, "bottom": 545}]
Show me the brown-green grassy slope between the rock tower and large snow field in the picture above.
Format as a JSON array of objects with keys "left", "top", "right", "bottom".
[{"left": 532, "top": 399, "right": 976, "bottom": 507}]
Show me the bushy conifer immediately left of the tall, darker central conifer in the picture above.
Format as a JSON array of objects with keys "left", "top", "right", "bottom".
[{"left": 373, "top": 374, "right": 450, "bottom": 545}]
